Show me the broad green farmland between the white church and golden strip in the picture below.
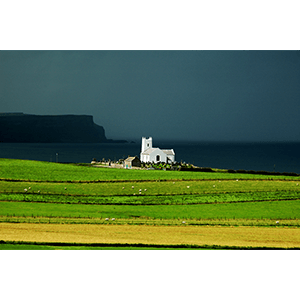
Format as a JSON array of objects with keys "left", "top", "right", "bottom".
[{"left": 0, "top": 159, "right": 300, "bottom": 249}]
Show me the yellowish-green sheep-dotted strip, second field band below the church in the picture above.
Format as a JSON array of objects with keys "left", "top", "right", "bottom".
[{"left": 0, "top": 180, "right": 300, "bottom": 196}]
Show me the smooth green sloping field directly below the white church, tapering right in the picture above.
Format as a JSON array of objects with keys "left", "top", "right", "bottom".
[{"left": 0, "top": 158, "right": 300, "bottom": 182}]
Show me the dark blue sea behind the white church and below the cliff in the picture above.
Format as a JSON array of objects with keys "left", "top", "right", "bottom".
[{"left": 0, "top": 141, "right": 300, "bottom": 174}]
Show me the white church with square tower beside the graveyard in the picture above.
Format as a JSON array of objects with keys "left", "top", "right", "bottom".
[{"left": 140, "top": 137, "right": 175, "bottom": 163}]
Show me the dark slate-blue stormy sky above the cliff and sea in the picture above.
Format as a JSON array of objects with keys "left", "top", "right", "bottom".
[{"left": 0, "top": 50, "right": 300, "bottom": 141}]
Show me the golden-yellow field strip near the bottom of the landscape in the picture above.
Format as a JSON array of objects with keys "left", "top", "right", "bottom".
[{"left": 0, "top": 223, "right": 300, "bottom": 248}]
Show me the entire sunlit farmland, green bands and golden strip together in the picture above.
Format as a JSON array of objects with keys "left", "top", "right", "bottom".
[{"left": 0, "top": 159, "right": 300, "bottom": 249}]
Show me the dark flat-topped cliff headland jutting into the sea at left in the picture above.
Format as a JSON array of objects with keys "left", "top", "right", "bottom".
[{"left": 0, "top": 113, "right": 108, "bottom": 143}]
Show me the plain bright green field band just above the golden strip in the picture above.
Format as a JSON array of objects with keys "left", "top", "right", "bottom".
[{"left": 0, "top": 200, "right": 300, "bottom": 222}]
